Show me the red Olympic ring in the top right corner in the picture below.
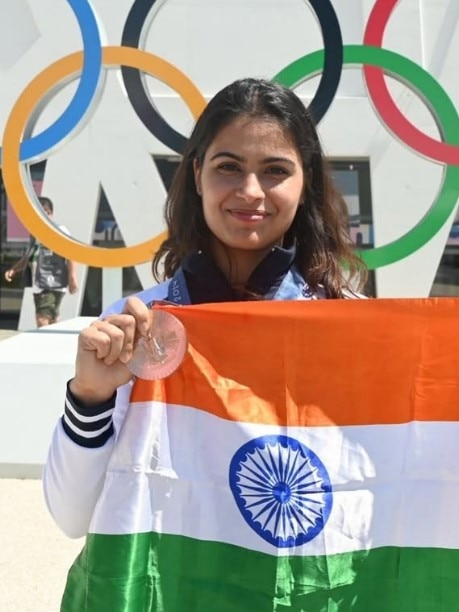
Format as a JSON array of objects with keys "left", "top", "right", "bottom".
[{"left": 363, "top": 0, "right": 459, "bottom": 166}]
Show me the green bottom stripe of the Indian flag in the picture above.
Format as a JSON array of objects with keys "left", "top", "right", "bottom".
[{"left": 61, "top": 534, "right": 459, "bottom": 612}]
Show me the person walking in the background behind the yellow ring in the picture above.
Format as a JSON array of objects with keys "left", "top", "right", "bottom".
[{"left": 5, "top": 197, "right": 78, "bottom": 327}]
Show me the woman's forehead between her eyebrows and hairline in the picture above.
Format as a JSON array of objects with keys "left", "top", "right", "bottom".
[{"left": 208, "top": 117, "right": 298, "bottom": 155}]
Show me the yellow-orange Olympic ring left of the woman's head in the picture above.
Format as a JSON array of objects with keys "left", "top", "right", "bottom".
[{"left": 2, "top": 47, "right": 206, "bottom": 268}]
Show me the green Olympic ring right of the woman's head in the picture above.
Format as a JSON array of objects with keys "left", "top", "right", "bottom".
[{"left": 273, "top": 45, "right": 459, "bottom": 270}]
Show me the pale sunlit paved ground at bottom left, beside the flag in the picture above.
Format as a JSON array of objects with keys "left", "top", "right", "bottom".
[{"left": 0, "top": 479, "right": 84, "bottom": 612}]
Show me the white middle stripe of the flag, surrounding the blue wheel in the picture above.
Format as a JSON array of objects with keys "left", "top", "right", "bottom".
[{"left": 90, "top": 403, "right": 459, "bottom": 555}]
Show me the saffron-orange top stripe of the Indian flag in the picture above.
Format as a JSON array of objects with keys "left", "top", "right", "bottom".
[{"left": 131, "top": 298, "right": 459, "bottom": 427}]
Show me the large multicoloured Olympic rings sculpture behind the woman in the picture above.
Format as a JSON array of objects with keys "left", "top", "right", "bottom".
[{"left": 0, "top": 0, "right": 459, "bottom": 269}]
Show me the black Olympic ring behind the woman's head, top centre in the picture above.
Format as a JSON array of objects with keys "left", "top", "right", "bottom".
[{"left": 121, "top": 0, "right": 343, "bottom": 153}]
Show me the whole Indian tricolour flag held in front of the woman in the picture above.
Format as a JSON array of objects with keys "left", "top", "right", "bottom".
[{"left": 62, "top": 299, "right": 459, "bottom": 612}]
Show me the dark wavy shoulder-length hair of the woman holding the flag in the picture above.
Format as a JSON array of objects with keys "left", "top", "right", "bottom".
[{"left": 152, "top": 78, "right": 367, "bottom": 298}]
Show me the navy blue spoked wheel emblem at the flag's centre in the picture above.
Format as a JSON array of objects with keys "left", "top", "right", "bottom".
[{"left": 229, "top": 436, "right": 333, "bottom": 548}]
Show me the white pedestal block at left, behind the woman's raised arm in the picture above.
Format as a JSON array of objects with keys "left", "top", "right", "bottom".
[{"left": 0, "top": 317, "right": 94, "bottom": 478}]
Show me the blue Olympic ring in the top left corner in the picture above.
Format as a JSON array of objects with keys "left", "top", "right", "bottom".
[{"left": 0, "top": 0, "right": 102, "bottom": 163}]
